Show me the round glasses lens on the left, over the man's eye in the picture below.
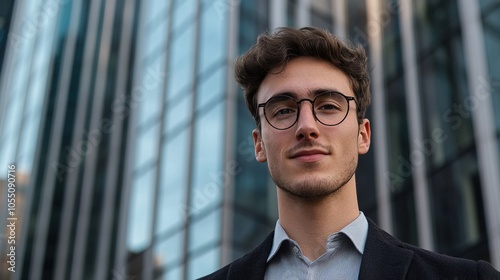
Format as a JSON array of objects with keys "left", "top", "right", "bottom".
[{"left": 264, "top": 96, "right": 298, "bottom": 129}]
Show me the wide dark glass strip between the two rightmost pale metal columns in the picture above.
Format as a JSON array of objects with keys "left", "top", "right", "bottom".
[{"left": 414, "top": 1, "right": 488, "bottom": 258}]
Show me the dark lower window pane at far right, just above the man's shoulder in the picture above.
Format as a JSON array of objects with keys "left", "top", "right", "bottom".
[{"left": 430, "top": 153, "right": 486, "bottom": 256}]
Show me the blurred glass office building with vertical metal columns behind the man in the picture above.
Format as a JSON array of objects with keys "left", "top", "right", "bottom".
[{"left": 0, "top": 0, "right": 500, "bottom": 280}]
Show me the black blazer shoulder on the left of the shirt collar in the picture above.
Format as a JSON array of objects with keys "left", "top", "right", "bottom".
[{"left": 199, "top": 231, "right": 274, "bottom": 280}]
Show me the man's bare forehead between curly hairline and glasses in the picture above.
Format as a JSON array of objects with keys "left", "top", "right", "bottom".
[{"left": 257, "top": 57, "right": 354, "bottom": 103}]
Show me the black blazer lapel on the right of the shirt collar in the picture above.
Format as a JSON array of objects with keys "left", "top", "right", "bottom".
[{"left": 359, "top": 219, "right": 413, "bottom": 279}]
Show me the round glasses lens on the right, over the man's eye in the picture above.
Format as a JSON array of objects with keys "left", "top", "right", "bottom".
[{"left": 314, "top": 92, "right": 349, "bottom": 125}]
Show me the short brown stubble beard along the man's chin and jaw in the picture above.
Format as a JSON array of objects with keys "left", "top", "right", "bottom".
[{"left": 270, "top": 157, "right": 358, "bottom": 200}]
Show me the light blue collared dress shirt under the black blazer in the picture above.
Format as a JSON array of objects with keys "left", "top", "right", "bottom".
[{"left": 264, "top": 212, "right": 368, "bottom": 280}]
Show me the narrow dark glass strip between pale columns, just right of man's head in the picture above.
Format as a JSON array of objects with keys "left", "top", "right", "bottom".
[{"left": 382, "top": 1, "right": 418, "bottom": 244}]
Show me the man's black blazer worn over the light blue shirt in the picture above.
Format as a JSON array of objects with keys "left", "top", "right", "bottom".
[{"left": 200, "top": 220, "right": 500, "bottom": 280}]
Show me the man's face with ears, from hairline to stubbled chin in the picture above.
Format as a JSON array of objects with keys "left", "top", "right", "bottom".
[{"left": 252, "top": 57, "right": 370, "bottom": 198}]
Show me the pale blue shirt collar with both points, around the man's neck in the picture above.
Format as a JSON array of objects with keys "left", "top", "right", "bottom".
[{"left": 267, "top": 211, "right": 368, "bottom": 262}]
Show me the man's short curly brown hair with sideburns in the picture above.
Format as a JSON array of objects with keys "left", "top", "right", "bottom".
[{"left": 235, "top": 27, "right": 370, "bottom": 129}]
